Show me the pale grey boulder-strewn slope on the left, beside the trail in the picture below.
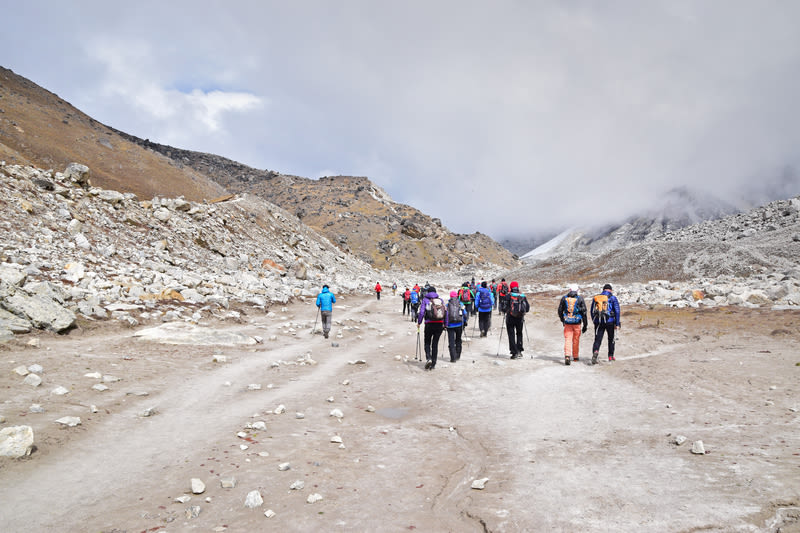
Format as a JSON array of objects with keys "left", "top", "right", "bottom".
[{"left": 0, "top": 162, "right": 377, "bottom": 338}]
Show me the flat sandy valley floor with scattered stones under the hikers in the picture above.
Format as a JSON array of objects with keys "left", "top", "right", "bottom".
[{"left": 0, "top": 294, "right": 800, "bottom": 532}]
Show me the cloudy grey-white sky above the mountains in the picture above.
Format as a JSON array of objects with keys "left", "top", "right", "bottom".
[{"left": 0, "top": 0, "right": 800, "bottom": 238}]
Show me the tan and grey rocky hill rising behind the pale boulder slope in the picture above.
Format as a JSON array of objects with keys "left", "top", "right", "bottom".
[{"left": 108, "top": 133, "right": 517, "bottom": 271}]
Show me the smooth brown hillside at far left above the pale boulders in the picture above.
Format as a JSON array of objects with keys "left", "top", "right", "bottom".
[{"left": 0, "top": 67, "right": 226, "bottom": 201}]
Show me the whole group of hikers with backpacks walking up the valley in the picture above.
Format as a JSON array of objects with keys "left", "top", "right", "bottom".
[{"left": 315, "top": 278, "right": 621, "bottom": 370}]
